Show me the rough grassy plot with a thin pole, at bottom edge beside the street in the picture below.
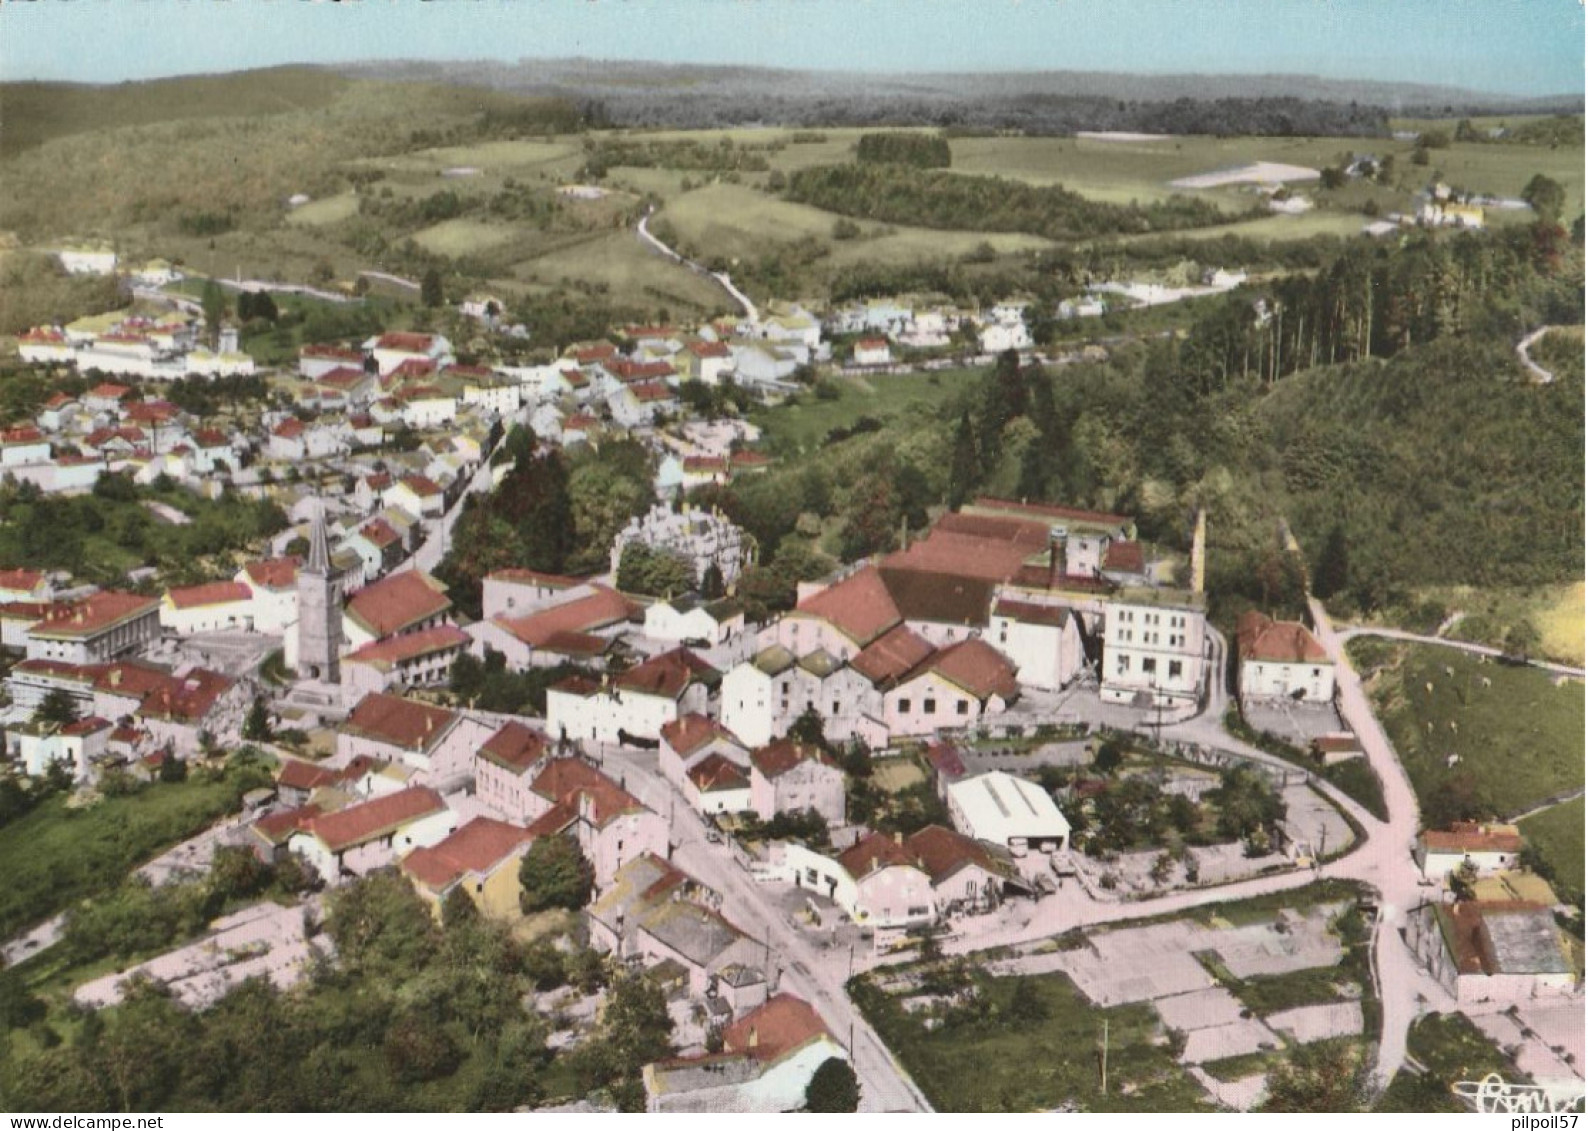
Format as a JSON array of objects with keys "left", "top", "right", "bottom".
[{"left": 854, "top": 972, "right": 1210, "bottom": 1112}]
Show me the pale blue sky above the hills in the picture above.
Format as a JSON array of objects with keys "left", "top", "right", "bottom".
[{"left": 0, "top": 0, "right": 1583, "bottom": 94}]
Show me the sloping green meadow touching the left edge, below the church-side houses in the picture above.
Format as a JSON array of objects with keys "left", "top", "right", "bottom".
[{"left": 0, "top": 770, "right": 241, "bottom": 937}]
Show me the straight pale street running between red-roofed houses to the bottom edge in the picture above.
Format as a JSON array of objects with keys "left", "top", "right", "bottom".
[{"left": 603, "top": 748, "right": 932, "bottom": 1112}]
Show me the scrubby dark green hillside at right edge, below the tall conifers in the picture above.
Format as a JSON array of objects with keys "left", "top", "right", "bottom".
[{"left": 1258, "top": 338, "right": 1583, "bottom": 607}]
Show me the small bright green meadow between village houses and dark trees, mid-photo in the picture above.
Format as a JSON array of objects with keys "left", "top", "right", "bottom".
[{"left": 751, "top": 369, "right": 983, "bottom": 454}]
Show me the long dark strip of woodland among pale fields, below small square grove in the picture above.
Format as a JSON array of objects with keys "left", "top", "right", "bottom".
[{"left": 788, "top": 165, "right": 1229, "bottom": 240}]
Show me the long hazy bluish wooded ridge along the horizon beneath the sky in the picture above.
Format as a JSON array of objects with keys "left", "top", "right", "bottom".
[{"left": 341, "top": 59, "right": 1583, "bottom": 135}]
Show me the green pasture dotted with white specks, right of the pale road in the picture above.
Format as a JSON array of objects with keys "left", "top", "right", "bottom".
[{"left": 1350, "top": 640, "right": 1583, "bottom": 816}]
